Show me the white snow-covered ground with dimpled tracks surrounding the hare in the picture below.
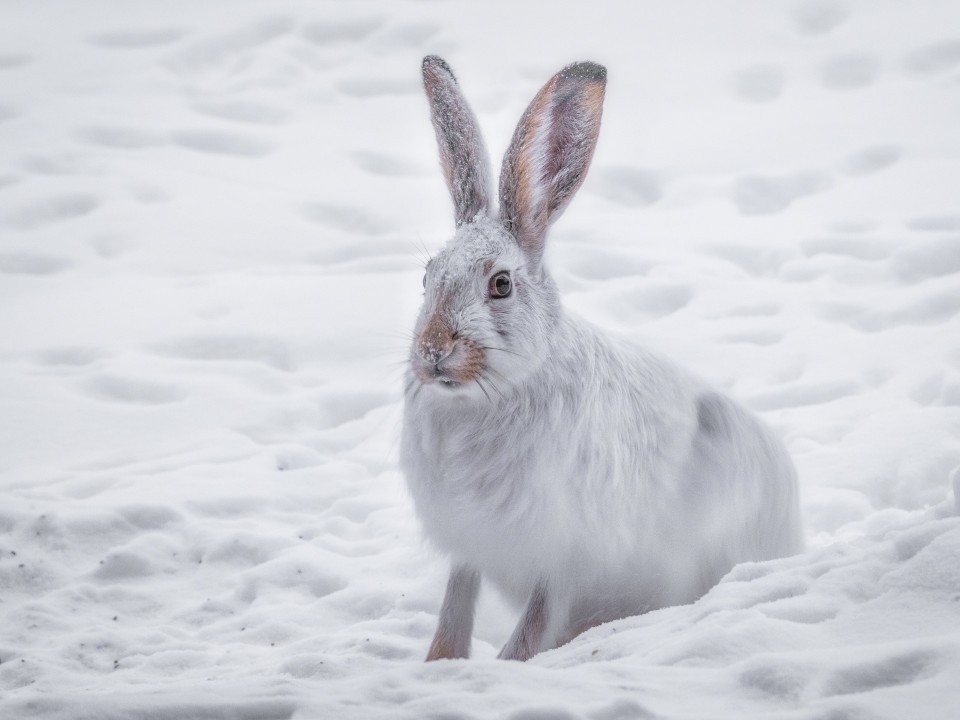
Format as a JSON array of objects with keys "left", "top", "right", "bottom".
[{"left": 0, "top": 0, "right": 960, "bottom": 720}]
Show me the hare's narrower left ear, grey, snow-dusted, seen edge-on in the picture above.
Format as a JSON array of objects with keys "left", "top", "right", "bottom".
[{"left": 423, "top": 55, "right": 492, "bottom": 227}]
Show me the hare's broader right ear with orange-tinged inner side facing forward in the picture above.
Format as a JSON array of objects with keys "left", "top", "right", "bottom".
[{"left": 500, "top": 62, "right": 607, "bottom": 264}]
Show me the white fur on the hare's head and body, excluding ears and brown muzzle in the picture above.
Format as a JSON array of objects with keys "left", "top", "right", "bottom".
[{"left": 401, "top": 60, "right": 802, "bottom": 659}]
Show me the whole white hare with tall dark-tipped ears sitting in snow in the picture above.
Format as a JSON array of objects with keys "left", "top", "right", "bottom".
[{"left": 401, "top": 56, "right": 803, "bottom": 660}]
